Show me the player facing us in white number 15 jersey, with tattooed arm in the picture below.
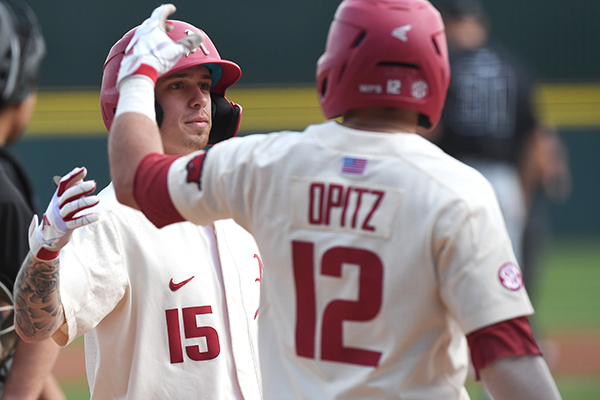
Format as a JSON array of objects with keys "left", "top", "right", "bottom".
[{"left": 15, "top": 21, "right": 262, "bottom": 400}]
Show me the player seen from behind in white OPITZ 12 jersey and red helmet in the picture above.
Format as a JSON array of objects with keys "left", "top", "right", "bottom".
[{"left": 109, "top": 0, "right": 560, "bottom": 400}]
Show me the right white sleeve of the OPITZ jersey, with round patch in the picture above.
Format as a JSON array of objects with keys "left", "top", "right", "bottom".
[{"left": 434, "top": 179, "right": 533, "bottom": 334}]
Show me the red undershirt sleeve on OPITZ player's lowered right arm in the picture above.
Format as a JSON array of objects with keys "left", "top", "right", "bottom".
[{"left": 467, "top": 317, "right": 542, "bottom": 380}]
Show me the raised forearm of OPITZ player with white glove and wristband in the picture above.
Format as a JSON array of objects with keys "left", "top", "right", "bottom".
[{"left": 108, "top": 4, "right": 203, "bottom": 209}]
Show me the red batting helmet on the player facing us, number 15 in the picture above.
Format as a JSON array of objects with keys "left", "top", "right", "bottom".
[{"left": 100, "top": 20, "right": 242, "bottom": 144}]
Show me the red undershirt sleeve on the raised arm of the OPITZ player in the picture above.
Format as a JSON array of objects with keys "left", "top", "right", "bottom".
[{"left": 133, "top": 153, "right": 184, "bottom": 228}]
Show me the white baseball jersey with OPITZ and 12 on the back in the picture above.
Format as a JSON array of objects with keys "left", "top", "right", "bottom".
[{"left": 149, "top": 122, "right": 533, "bottom": 400}]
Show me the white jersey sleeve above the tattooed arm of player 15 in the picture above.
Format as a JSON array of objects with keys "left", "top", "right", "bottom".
[{"left": 54, "top": 213, "right": 128, "bottom": 346}]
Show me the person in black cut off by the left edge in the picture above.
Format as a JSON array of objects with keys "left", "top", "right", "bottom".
[{"left": 0, "top": 0, "right": 65, "bottom": 400}]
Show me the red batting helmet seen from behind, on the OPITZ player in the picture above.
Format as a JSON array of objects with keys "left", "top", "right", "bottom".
[{"left": 317, "top": 0, "right": 450, "bottom": 128}]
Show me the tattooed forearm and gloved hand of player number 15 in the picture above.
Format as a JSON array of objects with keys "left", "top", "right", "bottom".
[{"left": 14, "top": 168, "right": 98, "bottom": 342}]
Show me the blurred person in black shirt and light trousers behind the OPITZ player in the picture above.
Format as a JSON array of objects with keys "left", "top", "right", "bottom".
[{"left": 428, "top": 0, "right": 538, "bottom": 263}]
